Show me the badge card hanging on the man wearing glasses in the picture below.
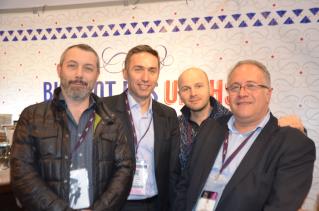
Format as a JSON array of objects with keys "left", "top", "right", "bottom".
[{"left": 195, "top": 190, "right": 218, "bottom": 211}]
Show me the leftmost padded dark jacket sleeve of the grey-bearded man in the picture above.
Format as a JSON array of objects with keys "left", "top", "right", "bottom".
[{"left": 10, "top": 109, "right": 72, "bottom": 211}]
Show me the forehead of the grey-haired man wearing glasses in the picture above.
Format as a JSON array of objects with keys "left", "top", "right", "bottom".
[{"left": 229, "top": 64, "right": 265, "bottom": 83}]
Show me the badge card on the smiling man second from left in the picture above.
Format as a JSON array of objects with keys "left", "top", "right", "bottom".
[{"left": 130, "top": 159, "right": 148, "bottom": 195}]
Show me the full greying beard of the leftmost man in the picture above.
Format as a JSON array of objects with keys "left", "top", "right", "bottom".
[{"left": 61, "top": 77, "right": 93, "bottom": 102}]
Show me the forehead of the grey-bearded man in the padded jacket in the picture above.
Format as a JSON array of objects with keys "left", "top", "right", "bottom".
[{"left": 64, "top": 47, "right": 97, "bottom": 64}]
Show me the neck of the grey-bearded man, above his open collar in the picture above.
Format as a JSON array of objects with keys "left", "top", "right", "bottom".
[{"left": 65, "top": 97, "right": 90, "bottom": 123}]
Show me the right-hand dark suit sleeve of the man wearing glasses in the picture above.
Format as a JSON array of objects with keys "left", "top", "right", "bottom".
[{"left": 264, "top": 128, "right": 316, "bottom": 211}]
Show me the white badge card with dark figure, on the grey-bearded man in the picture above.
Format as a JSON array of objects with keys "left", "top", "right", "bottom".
[{"left": 69, "top": 168, "right": 90, "bottom": 209}]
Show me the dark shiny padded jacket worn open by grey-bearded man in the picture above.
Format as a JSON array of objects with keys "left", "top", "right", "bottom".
[{"left": 11, "top": 88, "right": 135, "bottom": 211}]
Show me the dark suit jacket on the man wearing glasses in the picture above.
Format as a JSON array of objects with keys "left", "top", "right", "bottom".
[{"left": 176, "top": 115, "right": 316, "bottom": 211}]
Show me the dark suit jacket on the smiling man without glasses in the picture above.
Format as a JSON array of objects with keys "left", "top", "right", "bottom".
[{"left": 103, "top": 93, "right": 180, "bottom": 211}]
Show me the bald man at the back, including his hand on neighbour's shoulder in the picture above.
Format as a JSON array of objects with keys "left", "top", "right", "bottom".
[{"left": 178, "top": 67, "right": 305, "bottom": 169}]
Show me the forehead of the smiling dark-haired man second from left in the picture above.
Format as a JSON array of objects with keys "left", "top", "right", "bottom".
[{"left": 129, "top": 52, "right": 158, "bottom": 68}]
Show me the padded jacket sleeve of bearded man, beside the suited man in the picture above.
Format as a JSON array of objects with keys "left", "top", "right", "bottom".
[{"left": 93, "top": 119, "right": 135, "bottom": 211}]
